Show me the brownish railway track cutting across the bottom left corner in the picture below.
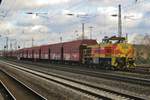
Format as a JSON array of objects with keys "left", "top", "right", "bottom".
[{"left": 0, "top": 70, "right": 47, "bottom": 100}]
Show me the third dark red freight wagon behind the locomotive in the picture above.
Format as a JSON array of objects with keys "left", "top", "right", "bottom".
[{"left": 41, "top": 45, "right": 50, "bottom": 59}]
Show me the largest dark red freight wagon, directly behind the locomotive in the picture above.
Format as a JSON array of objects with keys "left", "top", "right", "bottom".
[{"left": 63, "top": 39, "right": 97, "bottom": 62}]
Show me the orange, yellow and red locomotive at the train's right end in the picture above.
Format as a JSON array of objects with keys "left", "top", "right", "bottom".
[{"left": 83, "top": 36, "right": 134, "bottom": 69}]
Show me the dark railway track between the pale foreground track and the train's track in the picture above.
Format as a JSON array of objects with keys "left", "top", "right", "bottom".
[{"left": 7, "top": 59, "right": 150, "bottom": 86}]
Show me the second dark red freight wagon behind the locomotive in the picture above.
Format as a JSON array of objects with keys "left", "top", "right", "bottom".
[{"left": 50, "top": 43, "right": 63, "bottom": 60}]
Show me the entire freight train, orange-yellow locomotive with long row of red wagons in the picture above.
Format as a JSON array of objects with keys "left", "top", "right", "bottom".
[{"left": 5, "top": 36, "right": 134, "bottom": 69}]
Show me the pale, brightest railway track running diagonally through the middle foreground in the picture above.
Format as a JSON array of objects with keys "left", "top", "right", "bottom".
[{"left": 1, "top": 61, "right": 144, "bottom": 100}]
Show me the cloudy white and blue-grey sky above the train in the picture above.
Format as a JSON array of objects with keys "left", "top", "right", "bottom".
[{"left": 0, "top": 0, "right": 150, "bottom": 48}]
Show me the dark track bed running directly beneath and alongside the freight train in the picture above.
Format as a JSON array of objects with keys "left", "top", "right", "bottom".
[{"left": 2, "top": 59, "right": 150, "bottom": 79}]
